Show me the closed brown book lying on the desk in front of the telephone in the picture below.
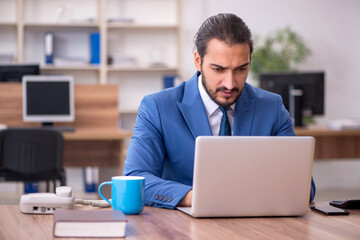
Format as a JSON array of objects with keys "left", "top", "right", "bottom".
[{"left": 54, "top": 210, "right": 127, "bottom": 237}]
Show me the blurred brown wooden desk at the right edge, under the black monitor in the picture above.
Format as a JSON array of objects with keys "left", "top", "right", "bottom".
[{"left": 295, "top": 127, "right": 360, "bottom": 159}]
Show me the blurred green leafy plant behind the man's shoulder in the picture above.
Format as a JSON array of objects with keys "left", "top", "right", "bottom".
[{"left": 250, "top": 27, "right": 311, "bottom": 80}]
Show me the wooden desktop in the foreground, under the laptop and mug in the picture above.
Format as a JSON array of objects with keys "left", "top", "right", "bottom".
[{"left": 0, "top": 205, "right": 360, "bottom": 240}]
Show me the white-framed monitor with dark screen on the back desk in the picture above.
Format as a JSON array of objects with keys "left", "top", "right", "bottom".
[{"left": 23, "top": 75, "right": 75, "bottom": 126}]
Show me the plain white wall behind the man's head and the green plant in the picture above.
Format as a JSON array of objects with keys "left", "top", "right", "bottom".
[{"left": 182, "top": 0, "right": 360, "bottom": 123}]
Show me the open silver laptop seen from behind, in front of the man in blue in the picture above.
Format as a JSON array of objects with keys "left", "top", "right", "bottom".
[{"left": 178, "top": 136, "right": 315, "bottom": 217}]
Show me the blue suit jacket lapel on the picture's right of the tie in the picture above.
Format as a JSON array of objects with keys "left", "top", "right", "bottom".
[{"left": 233, "top": 84, "right": 255, "bottom": 136}]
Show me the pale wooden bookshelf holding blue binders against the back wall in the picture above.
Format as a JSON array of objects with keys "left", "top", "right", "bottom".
[{"left": 0, "top": 0, "right": 181, "bottom": 114}]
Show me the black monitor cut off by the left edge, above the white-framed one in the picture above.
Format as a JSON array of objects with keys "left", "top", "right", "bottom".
[{"left": 0, "top": 64, "right": 40, "bottom": 82}]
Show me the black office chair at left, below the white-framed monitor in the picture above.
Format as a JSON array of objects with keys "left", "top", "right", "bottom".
[{"left": 0, "top": 128, "right": 66, "bottom": 192}]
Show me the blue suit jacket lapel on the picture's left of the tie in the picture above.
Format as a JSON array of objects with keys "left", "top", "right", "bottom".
[{"left": 177, "top": 72, "right": 212, "bottom": 138}]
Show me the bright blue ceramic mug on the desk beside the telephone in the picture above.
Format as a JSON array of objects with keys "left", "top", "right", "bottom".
[{"left": 99, "top": 176, "right": 145, "bottom": 215}]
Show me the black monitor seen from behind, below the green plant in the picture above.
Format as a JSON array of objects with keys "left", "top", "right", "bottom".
[{"left": 260, "top": 72, "right": 325, "bottom": 126}]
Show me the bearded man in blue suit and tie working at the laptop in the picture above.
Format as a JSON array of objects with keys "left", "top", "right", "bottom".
[{"left": 124, "top": 14, "right": 315, "bottom": 208}]
